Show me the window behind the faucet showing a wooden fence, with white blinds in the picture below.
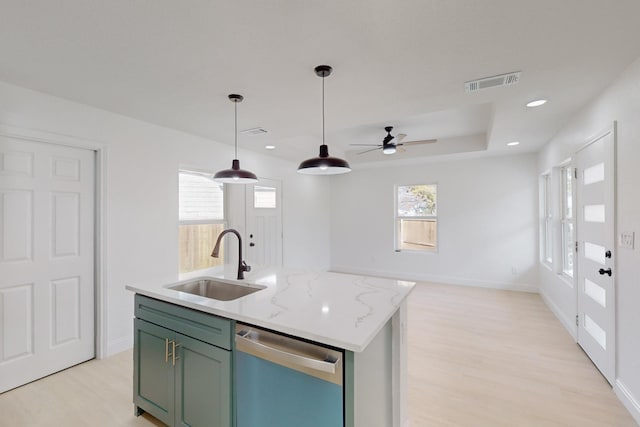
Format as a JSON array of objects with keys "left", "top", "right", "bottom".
[{"left": 178, "top": 171, "right": 225, "bottom": 273}]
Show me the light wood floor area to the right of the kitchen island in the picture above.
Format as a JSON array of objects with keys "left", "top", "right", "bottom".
[{"left": 408, "top": 284, "right": 636, "bottom": 427}]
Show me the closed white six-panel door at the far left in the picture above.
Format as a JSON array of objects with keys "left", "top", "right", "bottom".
[{"left": 0, "top": 136, "right": 95, "bottom": 392}]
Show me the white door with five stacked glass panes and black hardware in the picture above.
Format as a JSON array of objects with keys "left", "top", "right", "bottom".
[{"left": 576, "top": 130, "right": 616, "bottom": 383}]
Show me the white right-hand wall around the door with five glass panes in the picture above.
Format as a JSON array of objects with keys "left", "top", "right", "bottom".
[{"left": 538, "top": 59, "right": 640, "bottom": 423}]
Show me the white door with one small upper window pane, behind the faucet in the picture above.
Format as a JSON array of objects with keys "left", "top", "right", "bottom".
[{"left": 246, "top": 178, "right": 282, "bottom": 266}]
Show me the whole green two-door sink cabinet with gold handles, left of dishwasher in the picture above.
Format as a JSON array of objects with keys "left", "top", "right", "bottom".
[{"left": 134, "top": 295, "right": 234, "bottom": 427}]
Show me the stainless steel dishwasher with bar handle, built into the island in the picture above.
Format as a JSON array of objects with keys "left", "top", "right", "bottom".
[{"left": 234, "top": 324, "right": 344, "bottom": 427}]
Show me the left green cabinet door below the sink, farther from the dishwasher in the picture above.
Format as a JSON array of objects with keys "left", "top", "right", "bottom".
[{"left": 133, "top": 319, "right": 176, "bottom": 425}]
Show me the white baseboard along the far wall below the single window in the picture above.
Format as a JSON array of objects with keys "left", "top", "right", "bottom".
[{"left": 331, "top": 266, "right": 538, "bottom": 293}]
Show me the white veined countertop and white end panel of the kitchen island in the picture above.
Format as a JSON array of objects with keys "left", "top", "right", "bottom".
[{"left": 127, "top": 269, "right": 414, "bottom": 427}]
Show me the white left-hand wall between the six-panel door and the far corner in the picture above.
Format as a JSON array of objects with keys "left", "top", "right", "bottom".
[{"left": 0, "top": 82, "right": 330, "bottom": 354}]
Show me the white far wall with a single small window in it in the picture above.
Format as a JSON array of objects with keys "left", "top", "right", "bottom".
[{"left": 331, "top": 154, "right": 538, "bottom": 291}]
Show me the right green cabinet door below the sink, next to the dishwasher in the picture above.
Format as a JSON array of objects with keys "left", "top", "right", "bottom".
[{"left": 175, "top": 334, "right": 232, "bottom": 427}]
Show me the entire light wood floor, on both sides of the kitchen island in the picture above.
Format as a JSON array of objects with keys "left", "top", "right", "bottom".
[{"left": 0, "top": 283, "right": 636, "bottom": 427}]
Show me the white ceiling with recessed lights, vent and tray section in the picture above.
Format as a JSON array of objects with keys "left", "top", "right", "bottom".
[{"left": 0, "top": 0, "right": 640, "bottom": 165}]
